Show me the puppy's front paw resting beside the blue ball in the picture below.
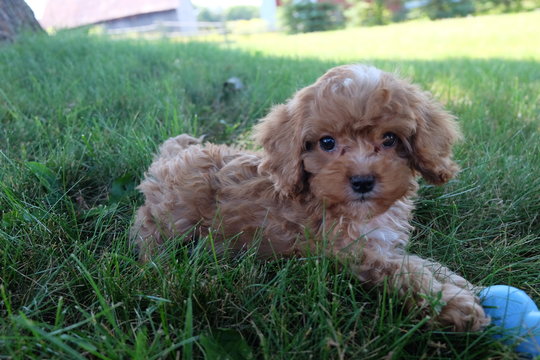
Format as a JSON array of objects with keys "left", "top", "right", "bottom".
[{"left": 435, "top": 284, "right": 489, "bottom": 331}]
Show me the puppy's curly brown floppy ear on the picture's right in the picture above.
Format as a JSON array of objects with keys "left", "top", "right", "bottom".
[{"left": 410, "top": 89, "right": 461, "bottom": 185}]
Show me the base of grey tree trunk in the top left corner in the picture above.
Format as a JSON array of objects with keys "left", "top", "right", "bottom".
[{"left": 0, "top": 0, "right": 43, "bottom": 41}]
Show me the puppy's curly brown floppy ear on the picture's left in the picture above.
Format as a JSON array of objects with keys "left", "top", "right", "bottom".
[{"left": 254, "top": 99, "right": 304, "bottom": 197}]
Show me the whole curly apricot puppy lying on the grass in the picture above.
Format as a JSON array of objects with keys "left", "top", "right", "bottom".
[{"left": 132, "top": 65, "right": 488, "bottom": 331}]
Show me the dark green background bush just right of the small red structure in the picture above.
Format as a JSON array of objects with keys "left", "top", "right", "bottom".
[{"left": 281, "top": 0, "right": 344, "bottom": 33}]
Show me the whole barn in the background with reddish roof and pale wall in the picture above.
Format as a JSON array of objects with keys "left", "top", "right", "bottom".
[{"left": 40, "top": 0, "right": 197, "bottom": 34}]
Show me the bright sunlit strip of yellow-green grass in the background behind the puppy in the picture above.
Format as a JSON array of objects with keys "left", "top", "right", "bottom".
[{"left": 234, "top": 11, "right": 540, "bottom": 61}]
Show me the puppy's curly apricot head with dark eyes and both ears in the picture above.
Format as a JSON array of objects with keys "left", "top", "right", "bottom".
[{"left": 255, "top": 65, "right": 460, "bottom": 215}]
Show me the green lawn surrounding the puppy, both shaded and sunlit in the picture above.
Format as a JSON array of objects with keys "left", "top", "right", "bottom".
[{"left": 0, "top": 13, "right": 540, "bottom": 359}]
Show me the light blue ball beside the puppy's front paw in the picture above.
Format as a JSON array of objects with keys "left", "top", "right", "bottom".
[{"left": 479, "top": 285, "right": 540, "bottom": 356}]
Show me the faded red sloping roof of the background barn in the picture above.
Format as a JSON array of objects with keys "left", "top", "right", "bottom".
[{"left": 40, "top": 0, "right": 182, "bottom": 28}]
